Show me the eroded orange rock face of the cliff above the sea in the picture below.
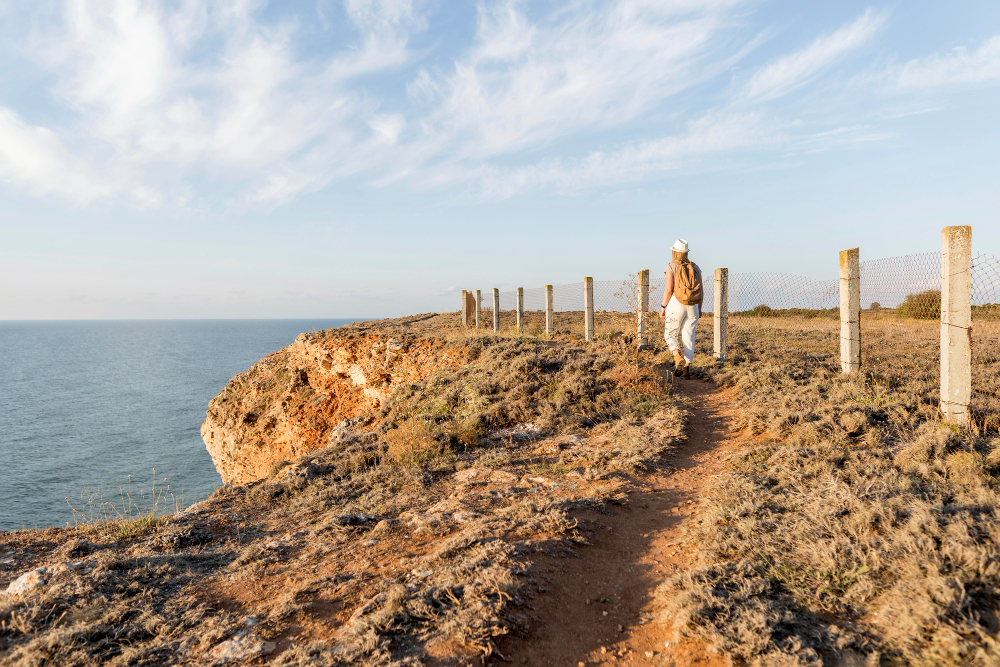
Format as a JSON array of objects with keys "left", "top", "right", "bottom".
[{"left": 201, "top": 332, "right": 458, "bottom": 484}]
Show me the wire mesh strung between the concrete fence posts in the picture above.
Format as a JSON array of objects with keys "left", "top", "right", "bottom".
[{"left": 470, "top": 252, "right": 1000, "bottom": 430}]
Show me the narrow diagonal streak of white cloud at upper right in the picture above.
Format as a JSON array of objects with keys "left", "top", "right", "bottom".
[{"left": 742, "top": 9, "right": 885, "bottom": 100}]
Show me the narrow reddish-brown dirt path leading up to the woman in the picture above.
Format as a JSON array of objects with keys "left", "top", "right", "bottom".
[{"left": 493, "top": 380, "right": 738, "bottom": 667}]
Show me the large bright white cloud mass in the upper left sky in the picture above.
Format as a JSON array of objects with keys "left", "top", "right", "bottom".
[{"left": 5, "top": 0, "right": 414, "bottom": 204}]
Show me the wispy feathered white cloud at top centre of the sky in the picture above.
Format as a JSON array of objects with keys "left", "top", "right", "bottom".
[{"left": 411, "top": 1, "right": 752, "bottom": 159}]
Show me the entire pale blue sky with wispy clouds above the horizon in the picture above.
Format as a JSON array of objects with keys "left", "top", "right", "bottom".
[{"left": 0, "top": 0, "right": 1000, "bottom": 319}]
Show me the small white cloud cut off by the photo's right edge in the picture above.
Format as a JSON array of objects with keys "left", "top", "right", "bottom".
[{"left": 896, "top": 35, "right": 1000, "bottom": 90}]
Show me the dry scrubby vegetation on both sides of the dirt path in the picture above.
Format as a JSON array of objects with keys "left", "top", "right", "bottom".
[{"left": 0, "top": 312, "right": 1000, "bottom": 665}]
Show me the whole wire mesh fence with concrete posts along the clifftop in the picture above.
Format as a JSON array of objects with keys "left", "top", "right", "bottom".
[{"left": 463, "top": 227, "right": 1000, "bottom": 430}]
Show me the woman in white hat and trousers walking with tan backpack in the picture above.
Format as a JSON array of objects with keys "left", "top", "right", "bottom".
[{"left": 660, "top": 239, "right": 705, "bottom": 377}]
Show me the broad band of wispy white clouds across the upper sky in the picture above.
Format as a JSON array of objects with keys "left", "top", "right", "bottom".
[{"left": 0, "top": 0, "right": 1000, "bottom": 209}]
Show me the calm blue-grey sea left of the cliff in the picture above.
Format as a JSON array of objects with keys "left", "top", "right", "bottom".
[{"left": 0, "top": 319, "right": 353, "bottom": 530}]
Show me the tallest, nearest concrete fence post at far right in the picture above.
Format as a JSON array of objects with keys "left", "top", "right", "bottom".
[{"left": 941, "top": 226, "right": 972, "bottom": 426}]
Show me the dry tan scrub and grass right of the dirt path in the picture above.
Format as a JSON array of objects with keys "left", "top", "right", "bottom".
[{"left": 658, "top": 320, "right": 1000, "bottom": 665}]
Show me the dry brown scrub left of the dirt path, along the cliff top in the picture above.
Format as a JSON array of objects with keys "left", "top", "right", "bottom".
[{"left": 0, "top": 316, "right": 681, "bottom": 665}]
